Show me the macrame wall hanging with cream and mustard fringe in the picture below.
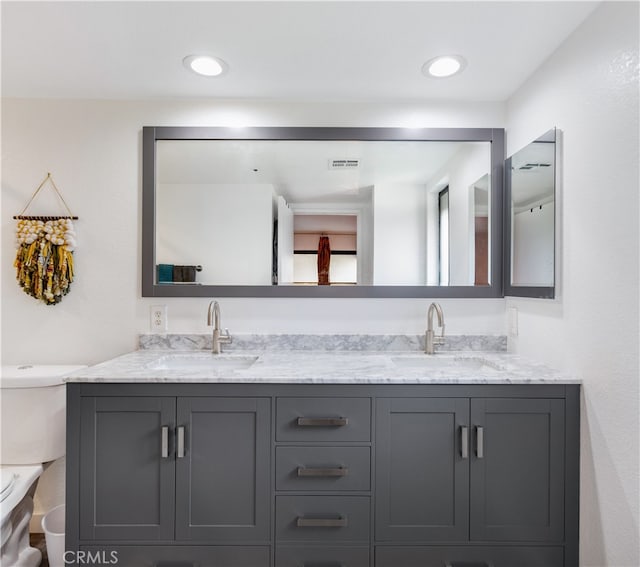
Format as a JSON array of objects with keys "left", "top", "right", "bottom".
[{"left": 13, "top": 173, "right": 78, "bottom": 305}]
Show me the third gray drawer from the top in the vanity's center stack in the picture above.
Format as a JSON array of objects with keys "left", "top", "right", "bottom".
[{"left": 276, "top": 496, "right": 370, "bottom": 542}]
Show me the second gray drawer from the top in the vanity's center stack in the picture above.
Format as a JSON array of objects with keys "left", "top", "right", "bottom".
[{"left": 276, "top": 447, "right": 371, "bottom": 490}]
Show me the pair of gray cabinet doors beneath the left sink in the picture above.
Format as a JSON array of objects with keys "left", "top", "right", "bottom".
[{"left": 74, "top": 396, "right": 271, "bottom": 552}]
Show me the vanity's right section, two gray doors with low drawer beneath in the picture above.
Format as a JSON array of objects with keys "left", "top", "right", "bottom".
[{"left": 376, "top": 397, "right": 576, "bottom": 567}]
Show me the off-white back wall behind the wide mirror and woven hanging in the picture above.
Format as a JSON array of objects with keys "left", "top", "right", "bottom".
[{"left": 2, "top": 99, "right": 504, "bottom": 364}]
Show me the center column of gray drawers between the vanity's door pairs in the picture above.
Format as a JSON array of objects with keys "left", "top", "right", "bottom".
[{"left": 274, "top": 398, "right": 372, "bottom": 567}]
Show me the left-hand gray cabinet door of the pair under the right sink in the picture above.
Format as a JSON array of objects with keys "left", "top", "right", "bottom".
[{"left": 376, "top": 398, "right": 469, "bottom": 542}]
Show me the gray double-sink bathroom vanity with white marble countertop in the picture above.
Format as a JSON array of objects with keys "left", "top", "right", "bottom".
[{"left": 66, "top": 351, "right": 580, "bottom": 567}]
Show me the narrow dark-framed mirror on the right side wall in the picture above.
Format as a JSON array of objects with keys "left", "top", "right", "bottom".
[{"left": 505, "top": 128, "right": 558, "bottom": 299}]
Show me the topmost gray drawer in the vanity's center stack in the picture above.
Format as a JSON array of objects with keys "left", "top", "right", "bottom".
[{"left": 276, "top": 398, "right": 371, "bottom": 441}]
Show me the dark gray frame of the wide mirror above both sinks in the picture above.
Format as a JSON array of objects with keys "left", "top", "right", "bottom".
[{"left": 142, "top": 126, "right": 505, "bottom": 298}]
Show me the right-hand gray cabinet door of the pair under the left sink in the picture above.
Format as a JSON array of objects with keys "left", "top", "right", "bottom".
[{"left": 176, "top": 397, "right": 271, "bottom": 543}]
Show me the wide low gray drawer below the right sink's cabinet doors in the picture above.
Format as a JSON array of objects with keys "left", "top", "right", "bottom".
[{"left": 376, "top": 546, "right": 564, "bottom": 567}]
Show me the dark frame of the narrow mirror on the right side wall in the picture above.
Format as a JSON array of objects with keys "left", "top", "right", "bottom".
[{"left": 503, "top": 128, "right": 561, "bottom": 299}]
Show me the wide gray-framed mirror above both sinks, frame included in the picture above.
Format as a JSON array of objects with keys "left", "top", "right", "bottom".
[{"left": 142, "top": 127, "right": 504, "bottom": 297}]
